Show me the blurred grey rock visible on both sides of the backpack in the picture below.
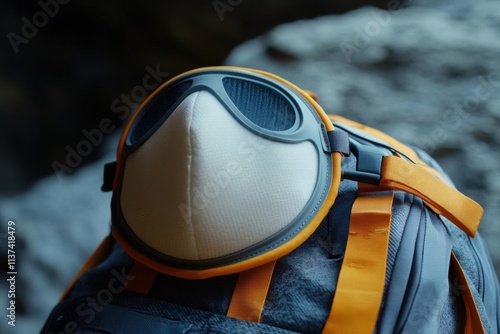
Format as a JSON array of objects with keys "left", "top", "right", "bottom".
[{"left": 0, "top": 1, "right": 500, "bottom": 333}]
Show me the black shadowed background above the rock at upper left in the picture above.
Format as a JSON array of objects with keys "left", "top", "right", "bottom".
[{"left": 0, "top": 0, "right": 386, "bottom": 194}]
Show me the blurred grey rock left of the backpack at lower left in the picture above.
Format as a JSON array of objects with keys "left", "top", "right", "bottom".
[{"left": 0, "top": 136, "right": 117, "bottom": 334}]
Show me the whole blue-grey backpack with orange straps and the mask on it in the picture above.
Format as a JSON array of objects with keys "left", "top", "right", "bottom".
[{"left": 42, "top": 66, "right": 500, "bottom": 334}]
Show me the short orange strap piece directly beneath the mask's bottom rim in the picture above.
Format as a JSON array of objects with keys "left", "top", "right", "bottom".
[{"left": 227, "top": 261, "right": 276, "bottom": 322}]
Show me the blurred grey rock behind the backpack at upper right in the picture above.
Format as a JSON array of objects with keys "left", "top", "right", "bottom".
[{"left": 226, "top": 1, "right": 500, "bottom": 273}]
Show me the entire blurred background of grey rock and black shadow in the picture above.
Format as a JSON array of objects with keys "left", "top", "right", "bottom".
[{"left": 0, "top": 0, "right": 500, "bottom": 333}]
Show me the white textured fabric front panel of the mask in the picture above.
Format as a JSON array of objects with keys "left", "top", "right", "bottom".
[{"left": 121, "top": 91, "right": 319, "bottom": 260}]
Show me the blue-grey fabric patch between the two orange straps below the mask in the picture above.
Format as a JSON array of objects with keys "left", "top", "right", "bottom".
[{"left": 261, "top": 222, "right": 342, "bottom": 333}]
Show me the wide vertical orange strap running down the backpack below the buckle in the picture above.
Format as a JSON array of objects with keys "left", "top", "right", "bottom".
[{"left": 323, "top": 192, "right": 394, "bottom": 334}]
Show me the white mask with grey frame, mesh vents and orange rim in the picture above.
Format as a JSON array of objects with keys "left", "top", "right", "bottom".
[{"left": 112, "top": 67, "right": 341, "bottom": 278}]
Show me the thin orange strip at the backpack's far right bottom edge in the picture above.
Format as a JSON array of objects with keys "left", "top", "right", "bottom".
[{"left": 451, "top": 253, "right": 486, "bottom": 334}]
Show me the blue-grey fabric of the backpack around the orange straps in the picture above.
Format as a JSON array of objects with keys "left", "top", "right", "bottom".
[{"left": 42, "top": 121, "right": 500, "bottom": 333}]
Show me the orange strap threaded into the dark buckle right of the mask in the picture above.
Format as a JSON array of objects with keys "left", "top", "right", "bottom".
[{"left": 380, "top": 156, "right": 483, "bottom": 237}]
